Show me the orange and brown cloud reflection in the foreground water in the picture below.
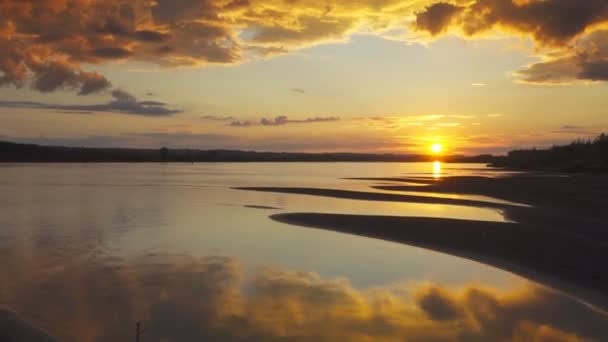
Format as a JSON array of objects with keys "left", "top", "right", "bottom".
[{"left": 3, "top": 255, "right": 608, "bottom": 341}]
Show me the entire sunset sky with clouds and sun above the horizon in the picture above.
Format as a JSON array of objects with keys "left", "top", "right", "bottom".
[{"left": 0, "top": 0, "right": 608, "bottom": 154}]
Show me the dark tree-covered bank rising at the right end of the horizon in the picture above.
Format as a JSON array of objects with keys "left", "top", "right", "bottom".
[{"left": 492, "top": 134, "right": 608, "bottom": 172}]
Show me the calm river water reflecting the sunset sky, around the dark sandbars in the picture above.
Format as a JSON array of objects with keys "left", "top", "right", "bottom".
[{"left": 0, "top": 163, "right": 608, "bottom": 341}]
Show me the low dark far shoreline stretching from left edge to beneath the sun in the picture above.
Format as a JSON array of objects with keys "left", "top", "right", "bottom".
[{"left": 0, "top": 141, "right": 494, "bottom": 163}]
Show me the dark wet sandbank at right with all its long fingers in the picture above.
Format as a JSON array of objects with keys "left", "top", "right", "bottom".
[{"left": 242, "top": 175, "right": 608, "bottom": 310}]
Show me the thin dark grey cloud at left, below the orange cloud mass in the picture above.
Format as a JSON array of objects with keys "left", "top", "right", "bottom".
[{"left": 0, "top": 89, "right": 181, "bottom": 117}]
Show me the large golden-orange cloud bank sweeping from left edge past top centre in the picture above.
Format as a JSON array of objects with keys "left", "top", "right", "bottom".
[{"left": 0, "top": 0, "right": 442, "bottom": 95}]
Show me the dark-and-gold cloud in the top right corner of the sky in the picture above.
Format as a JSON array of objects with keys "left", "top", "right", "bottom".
[{"left": 413, "top": 0, "right": 608, "bottom": 84}]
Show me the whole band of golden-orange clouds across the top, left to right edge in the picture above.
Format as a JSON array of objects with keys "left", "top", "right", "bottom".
[{"left": 0, "top": 0, "right": 608, "bottom": 95}]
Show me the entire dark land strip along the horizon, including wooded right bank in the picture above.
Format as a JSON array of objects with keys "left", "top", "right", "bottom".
[{"left": 0, "top": 133, "right": 608, "bottom": 173}]
